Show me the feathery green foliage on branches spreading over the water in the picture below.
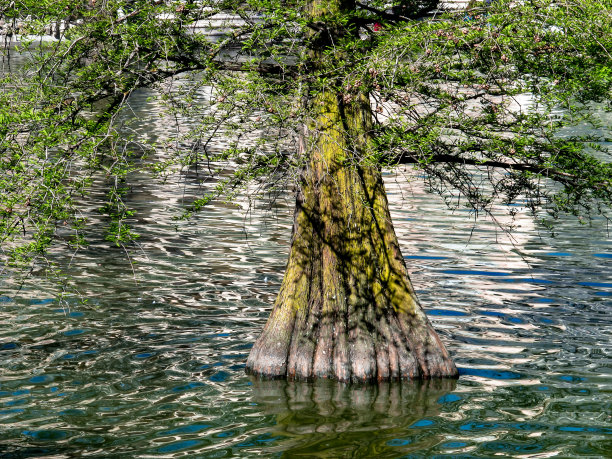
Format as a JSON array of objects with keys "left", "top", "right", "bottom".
[{"left": 0, "top": 0, "right": 612, "bottom": 274}]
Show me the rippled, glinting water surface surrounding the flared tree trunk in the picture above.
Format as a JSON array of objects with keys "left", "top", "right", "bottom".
[{"left": 0, "top": 66, "right": 612, "bottom": 458}]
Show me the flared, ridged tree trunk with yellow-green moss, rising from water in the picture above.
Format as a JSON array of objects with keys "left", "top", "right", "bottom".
[{"left": 247, "top": 92, "right": 457, "bottom": 381}]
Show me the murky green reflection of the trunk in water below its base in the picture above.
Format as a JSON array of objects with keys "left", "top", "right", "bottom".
[{"left": 253, "top": 379, "right": 456, "bottom": 457}]
